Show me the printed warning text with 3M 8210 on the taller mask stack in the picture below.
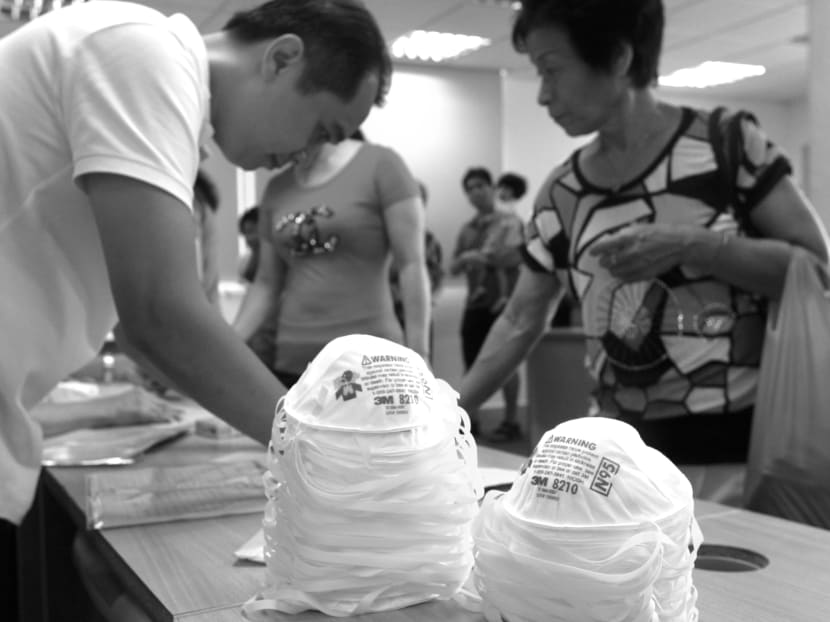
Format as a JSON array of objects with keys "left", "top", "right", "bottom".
[{"left": 361, "top": 355, "right": 432, "bottom": 415}]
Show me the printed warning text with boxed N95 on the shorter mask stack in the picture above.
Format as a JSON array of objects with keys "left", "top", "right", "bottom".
[{"left": 529, "top": 435, "right": 620, "bottom": 500}]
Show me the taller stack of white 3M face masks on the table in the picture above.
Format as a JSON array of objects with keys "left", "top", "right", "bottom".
[{"left": 255, "top": 335, "right": 482, "bottom": 616}]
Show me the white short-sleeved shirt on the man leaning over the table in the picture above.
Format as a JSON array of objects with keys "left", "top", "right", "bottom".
[{"left": 0, "top": 0, "right": 212, "bottom": 522}]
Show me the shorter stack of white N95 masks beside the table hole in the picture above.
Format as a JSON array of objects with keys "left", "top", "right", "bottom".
[{"left": 473, "top": 417, "right": 702, "bottom": 622}]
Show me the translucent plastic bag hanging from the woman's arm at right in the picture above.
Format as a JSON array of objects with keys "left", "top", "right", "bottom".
[{"left": 744, "top": 247, "right": 830, "bottom": 529}]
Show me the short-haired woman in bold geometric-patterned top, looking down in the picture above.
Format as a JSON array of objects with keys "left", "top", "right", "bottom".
[{"left": 460, "top": 0, "right": 827, "bottom": 500}]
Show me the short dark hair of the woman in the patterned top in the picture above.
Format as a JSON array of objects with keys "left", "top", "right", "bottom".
[{"left": 512, "top": 0, "right": 665, "bottom": 88}]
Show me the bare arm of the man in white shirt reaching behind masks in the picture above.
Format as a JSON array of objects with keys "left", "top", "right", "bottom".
[{"left": 82, "top": 174, "right": 285, "bottom": 443}]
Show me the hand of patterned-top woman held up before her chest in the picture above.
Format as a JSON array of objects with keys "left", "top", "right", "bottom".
[{"left": 590, "top": 223, "right": 708, "bottom": 282}]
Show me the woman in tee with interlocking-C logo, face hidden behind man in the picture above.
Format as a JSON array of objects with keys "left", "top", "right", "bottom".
[{"left": 233, "top": 129, "right": 430, "bottom": 387}]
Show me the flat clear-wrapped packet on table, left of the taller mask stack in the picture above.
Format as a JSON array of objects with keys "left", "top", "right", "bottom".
[{"left": 86, "top": 460, "right": 265, "bottom": 529}]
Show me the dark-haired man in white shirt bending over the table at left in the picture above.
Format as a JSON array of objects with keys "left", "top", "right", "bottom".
[{"left": 0, "top": 0, "right": 390, "bottom": 523}]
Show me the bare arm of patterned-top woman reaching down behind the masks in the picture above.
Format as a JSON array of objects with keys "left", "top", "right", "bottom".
[{"left": 459, "top": 266, "right": 565, "bottom": 411}]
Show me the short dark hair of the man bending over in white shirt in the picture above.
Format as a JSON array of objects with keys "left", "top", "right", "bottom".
[{"left": 224, "top": 0, "right": 392, "bottom": 106}]
